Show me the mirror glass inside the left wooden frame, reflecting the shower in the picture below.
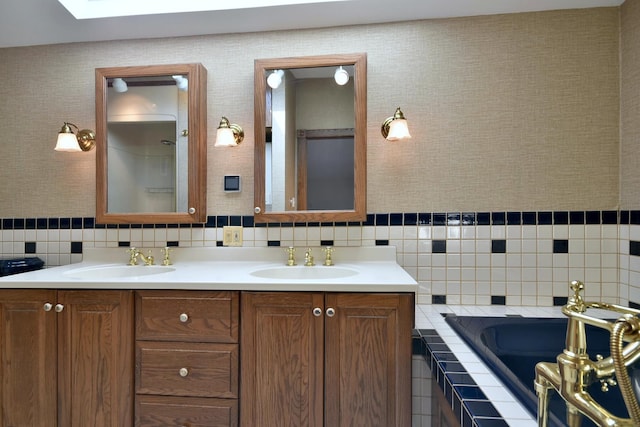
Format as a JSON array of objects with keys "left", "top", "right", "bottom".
[{"left": 107, "top": 75, "right": 189, "bottom": 213}]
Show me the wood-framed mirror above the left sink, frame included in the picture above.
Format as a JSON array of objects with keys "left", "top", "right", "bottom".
[{"left": 95, "top": 64, "right": 207, "bottom": 224}]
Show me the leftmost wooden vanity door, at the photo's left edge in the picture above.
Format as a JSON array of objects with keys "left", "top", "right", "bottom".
[{"left": 0, "top": 290, "right": 57, "bottom": 427}]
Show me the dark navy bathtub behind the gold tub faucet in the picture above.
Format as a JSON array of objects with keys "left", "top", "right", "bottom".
[{"left": 445, "top": 314, "right": 638, "bottom": 427}]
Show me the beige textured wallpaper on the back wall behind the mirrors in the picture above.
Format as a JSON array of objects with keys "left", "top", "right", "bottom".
[{"left": 0, "top": 7, "right": 624, "bottom": 217}]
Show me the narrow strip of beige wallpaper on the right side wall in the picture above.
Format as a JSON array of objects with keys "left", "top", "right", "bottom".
[{"left": 620, "top": 0, "right": 640, "bottom": 209}]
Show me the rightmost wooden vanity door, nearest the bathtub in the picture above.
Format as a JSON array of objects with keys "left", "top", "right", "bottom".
[{"left": 325, "top": 293, "right": 414, "bottom": 427}]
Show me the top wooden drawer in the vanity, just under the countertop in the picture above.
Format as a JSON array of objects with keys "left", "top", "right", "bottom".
[{"left": 136, "top": 291, "right": 240, "bottom": 343}]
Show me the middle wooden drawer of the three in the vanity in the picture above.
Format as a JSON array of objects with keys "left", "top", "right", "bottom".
[{"left": 136, "top": 341, "right": 238, "bottom": 398}]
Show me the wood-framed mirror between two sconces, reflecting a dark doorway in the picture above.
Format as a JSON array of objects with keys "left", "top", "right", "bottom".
[{"left": 254, "top": 53, "right": 367, "bottom": 222}]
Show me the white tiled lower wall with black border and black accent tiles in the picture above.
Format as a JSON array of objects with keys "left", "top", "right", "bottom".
[{"left": 0, "top": 211, "right": 640, "bottom": 306}]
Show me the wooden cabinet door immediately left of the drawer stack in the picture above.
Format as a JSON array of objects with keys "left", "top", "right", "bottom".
[{"left": 57, "top": 290, "right": 134, "bottom": 427}]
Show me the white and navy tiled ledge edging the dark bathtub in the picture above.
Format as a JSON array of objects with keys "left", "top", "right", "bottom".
[{"left": 413, "top": 305, "right": 564, "bottom": 427}]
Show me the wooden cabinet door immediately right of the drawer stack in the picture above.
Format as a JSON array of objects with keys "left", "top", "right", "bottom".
[{"left": 240, "top": 292, "right": 324, "bottom": 427}]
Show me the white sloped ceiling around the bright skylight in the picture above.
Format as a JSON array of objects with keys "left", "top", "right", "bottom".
[{"left": 0, "top": 0, "right": 624, "bottom": 48}]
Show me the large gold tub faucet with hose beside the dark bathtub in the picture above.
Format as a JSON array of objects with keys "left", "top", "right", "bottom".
[{"left": 534, "top": 281, "right": 640, "bottom": 427}]
